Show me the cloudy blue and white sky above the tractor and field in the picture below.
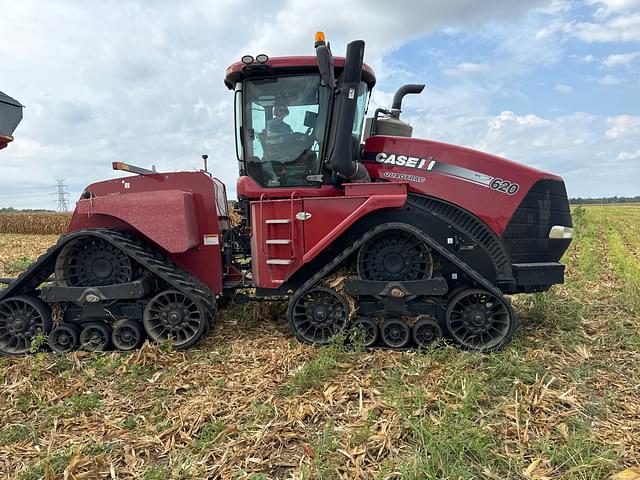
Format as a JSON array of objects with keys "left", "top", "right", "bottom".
[{"left": 0, "top": 0, "right": 640, "bottom": 208}]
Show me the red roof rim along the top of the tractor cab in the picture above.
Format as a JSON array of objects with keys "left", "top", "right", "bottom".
[{"left": 224, "top": 56, "right": 376, "bottom": 88}]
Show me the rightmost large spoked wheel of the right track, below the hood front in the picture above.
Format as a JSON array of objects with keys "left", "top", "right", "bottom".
[{"left": 445, "top": 288, "right": 516, "bottom": 352}]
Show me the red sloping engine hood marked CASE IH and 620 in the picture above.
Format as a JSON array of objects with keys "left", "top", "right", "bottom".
[{"left": 364, "top": 135, "right": 562, "bottom": 236}]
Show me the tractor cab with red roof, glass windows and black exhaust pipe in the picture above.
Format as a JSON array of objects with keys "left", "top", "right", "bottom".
[{"left": 225, "top": 35, "right": 375, "bottom": 198}]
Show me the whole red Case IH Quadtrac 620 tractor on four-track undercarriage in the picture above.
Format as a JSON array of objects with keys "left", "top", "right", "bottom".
[{"left": 0, "top": 33, "right": 572, "bottom": 354}]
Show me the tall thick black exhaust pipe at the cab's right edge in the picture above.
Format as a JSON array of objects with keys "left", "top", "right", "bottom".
[{"left": 329, "top": 40, "right": 370, "bottom": 182}]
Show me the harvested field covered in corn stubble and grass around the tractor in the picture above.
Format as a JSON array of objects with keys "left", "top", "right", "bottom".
[{"left": 0, "top": 206, "right": 640, "bottom": 480}]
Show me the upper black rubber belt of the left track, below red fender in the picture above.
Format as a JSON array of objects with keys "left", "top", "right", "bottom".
[{"left": 0, "top": 229, "right": 217, "bottom": 317}]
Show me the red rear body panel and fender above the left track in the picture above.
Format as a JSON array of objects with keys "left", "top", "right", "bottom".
[{"left": 68, "top": 172, "right": 222, "bottom": 293}]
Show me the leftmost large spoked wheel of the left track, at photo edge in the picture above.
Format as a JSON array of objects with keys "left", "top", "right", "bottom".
[{"left": 0, "top": 295, "right": 53, "bottom": 355}]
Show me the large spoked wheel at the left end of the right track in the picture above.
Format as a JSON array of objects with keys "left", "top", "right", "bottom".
[{"left": 287, "top": 287, "right": 349, "bottom": 345}]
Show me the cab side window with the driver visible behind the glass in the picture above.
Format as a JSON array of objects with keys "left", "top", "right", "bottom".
[{"left": 236, "top": 75, "right": 330, "bottom": 187}]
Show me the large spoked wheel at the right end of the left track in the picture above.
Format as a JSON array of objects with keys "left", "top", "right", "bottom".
[{"left": 142, "top": 290, "right": 209, "bottom": 348}]
